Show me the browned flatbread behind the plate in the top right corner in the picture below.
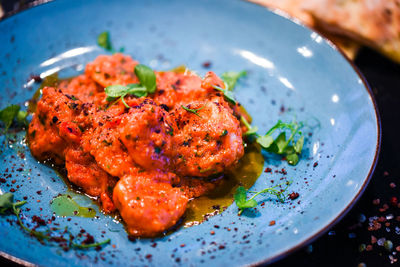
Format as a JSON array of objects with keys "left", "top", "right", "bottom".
[{"left": 249, "top": 0, "right": 400, "bottom": 62}]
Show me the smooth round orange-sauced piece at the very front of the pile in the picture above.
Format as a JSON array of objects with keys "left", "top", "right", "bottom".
[{"left": 113, "top": 172, "right": 188, "bottom": 237}]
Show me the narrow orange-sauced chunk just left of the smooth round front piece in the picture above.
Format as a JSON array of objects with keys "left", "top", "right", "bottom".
[{"left": 65, "top": 148, "right": 117, "bottom": 213}]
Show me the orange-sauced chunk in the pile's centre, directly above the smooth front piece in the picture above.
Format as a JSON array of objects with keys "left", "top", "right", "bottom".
[{"left": 118, "top": 99, "right": 175, "bottom": 170}]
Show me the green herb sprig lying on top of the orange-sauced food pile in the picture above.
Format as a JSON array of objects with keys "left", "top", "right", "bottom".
[{"left": 104, "top": 64, "right": 157, "bottom": 108}]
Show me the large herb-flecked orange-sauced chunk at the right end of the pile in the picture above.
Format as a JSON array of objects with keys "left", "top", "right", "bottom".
[{"left": 171, "top": 97, "right": 244, "bottom": 177}]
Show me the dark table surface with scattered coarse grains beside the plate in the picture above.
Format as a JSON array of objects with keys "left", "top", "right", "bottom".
[{"left": 0, "top": 0, "right": 400, "bottom": 267}]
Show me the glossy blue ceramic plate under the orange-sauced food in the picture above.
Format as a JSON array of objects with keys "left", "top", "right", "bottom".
[{"left": 0, "top": 0, "right": 380, "bottom": 266}]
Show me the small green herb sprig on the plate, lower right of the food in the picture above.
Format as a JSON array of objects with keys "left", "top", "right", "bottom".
[{"left": 234, "top": 181, "right": 291, "bottom": 215}]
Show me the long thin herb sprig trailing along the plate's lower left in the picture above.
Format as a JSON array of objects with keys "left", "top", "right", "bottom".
[{"left": 0, "top": 192, "right": 111, "bottom": 249}]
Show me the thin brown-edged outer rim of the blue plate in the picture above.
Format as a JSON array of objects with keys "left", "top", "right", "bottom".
[{"left": 0, "top": 0, "right": 382, "bottom": 267}]
